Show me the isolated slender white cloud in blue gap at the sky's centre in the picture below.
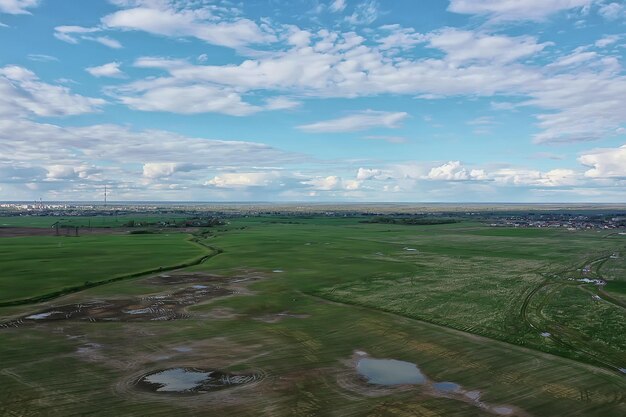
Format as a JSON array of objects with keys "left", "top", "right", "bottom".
[{"left": 298, "top": 110, "right": 408, "bottom": 133}]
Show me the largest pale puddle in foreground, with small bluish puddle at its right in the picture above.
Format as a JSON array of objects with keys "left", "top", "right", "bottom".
[{"left": 356, "top": 358, "right": 426, "bottom": 385}]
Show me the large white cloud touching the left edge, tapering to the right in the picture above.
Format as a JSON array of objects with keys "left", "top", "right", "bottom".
[{"left": 0, "top": 65, "right": 105, "bottom": 118}]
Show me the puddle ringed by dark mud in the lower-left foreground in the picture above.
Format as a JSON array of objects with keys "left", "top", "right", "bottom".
[{"left": 137, "top": 368, "right": 262, "bottom": 394}]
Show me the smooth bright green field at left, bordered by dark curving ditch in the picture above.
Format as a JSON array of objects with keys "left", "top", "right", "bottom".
[{"left": 0, "top": 233, "right": 205, "bottom": 302}]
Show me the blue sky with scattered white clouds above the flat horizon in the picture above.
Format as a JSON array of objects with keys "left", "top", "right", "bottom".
[{"left": 0, "top": 0, "right": 626, "bottom": 203}]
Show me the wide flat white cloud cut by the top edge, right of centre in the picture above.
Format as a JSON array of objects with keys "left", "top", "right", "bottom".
[{"left": 448, "top": 0, "right": 594, "bottom": 21}]
